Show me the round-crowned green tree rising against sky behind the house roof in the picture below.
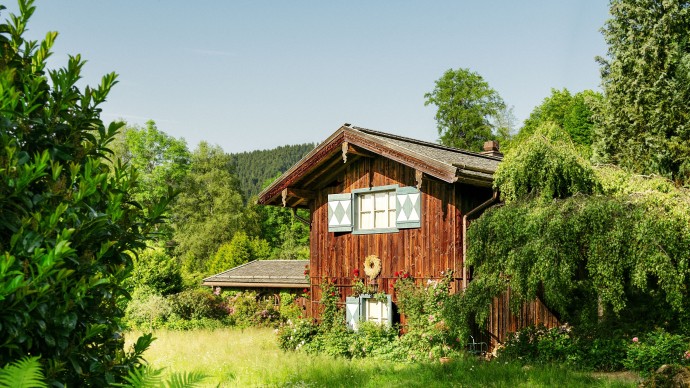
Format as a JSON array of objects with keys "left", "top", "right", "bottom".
[{"left": 424, "top": 69, "right": 506, "bottom": 151}]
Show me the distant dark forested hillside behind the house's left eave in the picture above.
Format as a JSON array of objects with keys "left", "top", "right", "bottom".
[{"left": 230, "top": 143, "right": 316, "bottom": 200}]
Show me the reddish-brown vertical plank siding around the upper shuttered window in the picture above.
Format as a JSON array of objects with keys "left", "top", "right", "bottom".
[{"left": 310, "top": 157, "right": 492, "bottom": 317}]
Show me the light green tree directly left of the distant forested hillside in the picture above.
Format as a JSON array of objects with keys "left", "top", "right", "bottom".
[{"left": 172, "top": 142, "right": 250, "bottom": 275}]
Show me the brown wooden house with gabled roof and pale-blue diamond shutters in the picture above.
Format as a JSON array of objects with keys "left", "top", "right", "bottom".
[{"left": 258, "top": 124, "right": 556, "bottom": 348}]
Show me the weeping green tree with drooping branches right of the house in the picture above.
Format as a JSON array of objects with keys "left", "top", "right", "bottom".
[{"left": 463, "top": 123, "right": 690, "bottom": 331}]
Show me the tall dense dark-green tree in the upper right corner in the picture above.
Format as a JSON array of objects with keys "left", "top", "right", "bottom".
[{"left": 595, "top": 0, "right": 690, "bottom": 184}]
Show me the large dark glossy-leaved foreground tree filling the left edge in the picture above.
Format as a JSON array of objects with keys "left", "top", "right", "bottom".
[{"left": 0, "top": 0, "right": 169, "bottom": 387}]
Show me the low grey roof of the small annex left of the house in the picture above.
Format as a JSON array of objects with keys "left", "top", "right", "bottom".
[{"left": 201, "top": 260, "right": 309, "bottom": 288}]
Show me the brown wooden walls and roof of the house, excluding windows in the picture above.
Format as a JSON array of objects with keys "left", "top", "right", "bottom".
[{"left": 259, "top": 125, "right": 558, "bottom": 345}]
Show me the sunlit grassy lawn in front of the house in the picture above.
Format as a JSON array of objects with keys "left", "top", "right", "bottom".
[{"left": 128, "top": 329, "right": 637, "bottom": 388}]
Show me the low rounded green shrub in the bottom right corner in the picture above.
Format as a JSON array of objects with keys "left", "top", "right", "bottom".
[{"left": 623, "top": 329, "right": 689, "bottom": 375}]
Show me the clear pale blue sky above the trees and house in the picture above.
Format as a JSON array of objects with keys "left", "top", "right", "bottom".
[{"left": 5, "top": 0, "right": 608, "bottom": 152}]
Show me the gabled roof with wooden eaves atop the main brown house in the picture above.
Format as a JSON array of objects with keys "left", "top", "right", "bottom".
[{"left": 258, "top": 124, "right": 502, "bottom": 207}]
